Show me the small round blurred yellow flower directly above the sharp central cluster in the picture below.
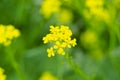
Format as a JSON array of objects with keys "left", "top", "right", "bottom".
[{"left": 58, "top": 9, "right": 73, "bottom": 23}]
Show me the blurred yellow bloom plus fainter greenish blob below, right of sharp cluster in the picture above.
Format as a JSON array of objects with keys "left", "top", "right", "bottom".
[{"left": 80, "top": 30, "right": 103, "bottom": 59}]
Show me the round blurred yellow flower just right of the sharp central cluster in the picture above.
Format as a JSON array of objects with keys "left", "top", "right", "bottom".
[{"left": 81, "top": 30, "right": 97, "bottom": 46}]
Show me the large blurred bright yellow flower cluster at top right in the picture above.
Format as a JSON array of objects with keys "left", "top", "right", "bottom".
[{"left": 84, "top": 0, "right": 110, "bottom": 22}]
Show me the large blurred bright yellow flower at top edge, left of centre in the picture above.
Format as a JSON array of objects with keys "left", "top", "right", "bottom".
[{"left": 40, "top": 0, "right": 61, "bottom": 19}]
